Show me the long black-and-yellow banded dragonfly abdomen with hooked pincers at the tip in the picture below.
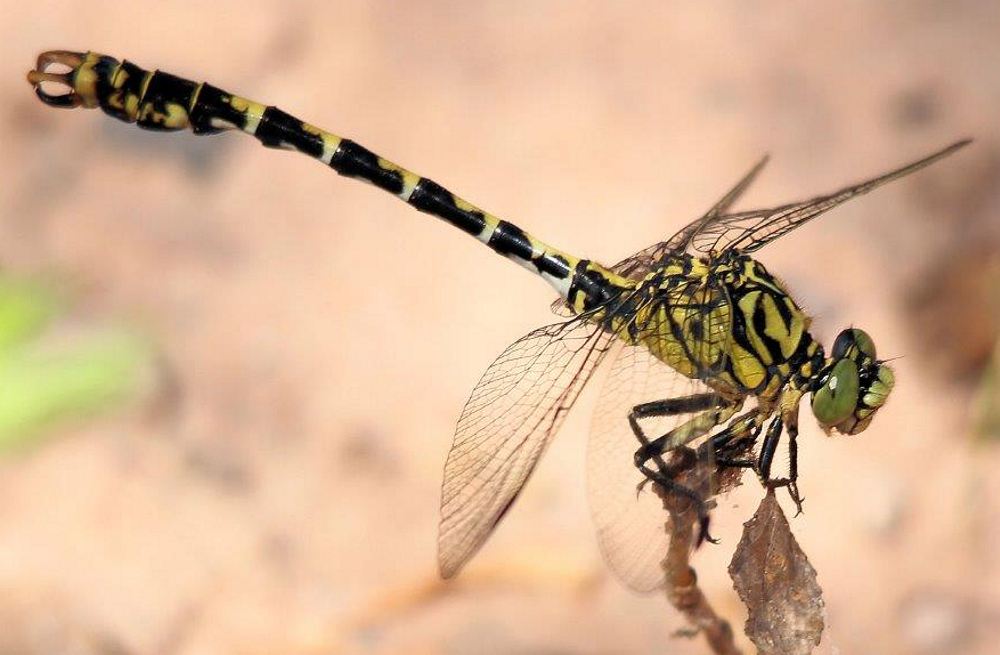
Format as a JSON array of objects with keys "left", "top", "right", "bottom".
[{"left": 35, "top": 51, "right": 625, "bottom": 312}]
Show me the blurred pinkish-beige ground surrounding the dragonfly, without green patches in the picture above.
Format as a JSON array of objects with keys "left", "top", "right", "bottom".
[{"left": 0, "top": 0, "right": 1000, "bottom": 655}]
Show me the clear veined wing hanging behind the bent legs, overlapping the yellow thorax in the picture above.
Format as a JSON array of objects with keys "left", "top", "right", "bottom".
[{"left": 587, "top": 274, "right": 731, "bottom": 592}]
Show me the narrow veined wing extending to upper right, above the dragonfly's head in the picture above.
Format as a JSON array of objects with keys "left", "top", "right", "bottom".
[{"left": 696, "top": 140, "right": 970, "bottom": 253}]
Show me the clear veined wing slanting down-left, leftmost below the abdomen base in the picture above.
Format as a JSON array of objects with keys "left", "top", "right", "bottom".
[{"left": 438, "top": 317, "right": 614, "bottom": 578}]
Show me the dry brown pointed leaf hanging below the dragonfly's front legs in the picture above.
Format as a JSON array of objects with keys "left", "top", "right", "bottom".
[{"left": 729, "top": 491, "right": 824, "bottom": 655}]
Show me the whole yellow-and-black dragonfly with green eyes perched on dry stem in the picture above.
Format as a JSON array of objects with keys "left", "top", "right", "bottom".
[{"left": 28, "top": 50, "right": 969, "bottom": 591}]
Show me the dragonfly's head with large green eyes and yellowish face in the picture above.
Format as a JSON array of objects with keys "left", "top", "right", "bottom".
[{"left": 812, "top": 328, "right": 895, "bottom": 434}]
